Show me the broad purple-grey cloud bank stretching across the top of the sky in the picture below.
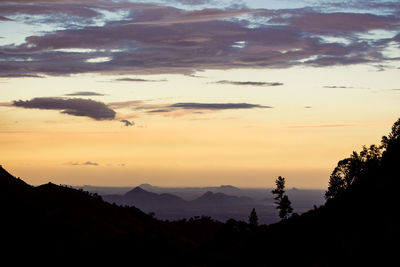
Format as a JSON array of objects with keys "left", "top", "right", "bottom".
[{"left": 0, "top": 0, "right": 400, "bottom": 77}]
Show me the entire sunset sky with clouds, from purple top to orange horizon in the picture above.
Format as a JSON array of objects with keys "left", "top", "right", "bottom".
[{"left": 0, "top": 0, "right": 400, "bottom": 189}]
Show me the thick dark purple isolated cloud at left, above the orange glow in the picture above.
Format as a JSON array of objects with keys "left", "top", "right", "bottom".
[{"left": 13, "top": 97, "right": 115, "bottom": 120}]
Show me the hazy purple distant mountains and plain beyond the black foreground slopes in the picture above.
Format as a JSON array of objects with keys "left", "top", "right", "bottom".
[{"left": 81, "top": 184, "right": 324, "bottom": 224}]
